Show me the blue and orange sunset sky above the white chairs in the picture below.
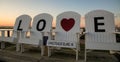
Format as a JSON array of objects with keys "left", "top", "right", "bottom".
[{"left": 0, "top": 0, "right": 120, "bottom": 27}]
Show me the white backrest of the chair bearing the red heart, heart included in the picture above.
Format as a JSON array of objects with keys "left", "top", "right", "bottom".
[{"left": 55, "top": 11, "right": 81, "bottom": 42}]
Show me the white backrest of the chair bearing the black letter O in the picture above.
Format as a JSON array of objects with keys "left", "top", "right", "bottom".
[{"left": 30, "top": 13, "right": 53, "bottom": 39}]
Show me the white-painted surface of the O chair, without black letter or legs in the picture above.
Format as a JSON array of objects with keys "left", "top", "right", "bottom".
[{"left": 19, "top": 13, "right": 53, "bottom": 45}]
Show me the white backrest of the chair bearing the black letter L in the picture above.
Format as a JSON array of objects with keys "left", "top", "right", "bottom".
[{"left": 13, "top": 15, "right": 32, "bottom": 37}]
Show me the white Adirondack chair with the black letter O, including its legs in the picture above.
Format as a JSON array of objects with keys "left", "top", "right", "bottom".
[{"left": 19, "top": 13, "right": 53, "bottom": 55}]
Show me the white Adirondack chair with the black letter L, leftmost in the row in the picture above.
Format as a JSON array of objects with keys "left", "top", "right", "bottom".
[{"left": 0, "top": 15, "right": 31, "bottom": 51}]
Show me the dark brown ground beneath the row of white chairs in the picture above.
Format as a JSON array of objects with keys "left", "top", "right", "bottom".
[{"left": 0, "top": 45, "right": 119, "bottom": 62}]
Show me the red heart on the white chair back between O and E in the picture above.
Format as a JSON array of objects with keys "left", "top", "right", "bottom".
[{"left": 61, "top": 18, "right": 75, "bottom": 31}]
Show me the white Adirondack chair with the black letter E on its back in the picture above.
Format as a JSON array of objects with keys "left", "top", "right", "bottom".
[{"left": 85, "top": 10, "right": 120, "bottom": 61}]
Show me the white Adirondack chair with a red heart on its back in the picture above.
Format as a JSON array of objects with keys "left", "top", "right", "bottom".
[{"left": 47, "top": 11, "right": 81, "bottom": 60}]
